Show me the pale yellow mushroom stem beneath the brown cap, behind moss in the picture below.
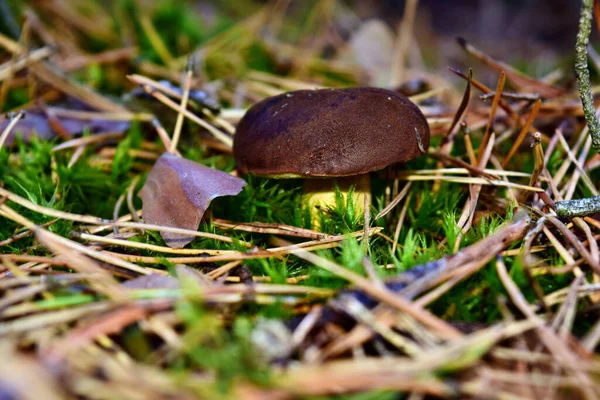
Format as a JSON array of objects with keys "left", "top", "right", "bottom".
[{"left": 302, "top": 173, "right": 371, "bottom": 230}]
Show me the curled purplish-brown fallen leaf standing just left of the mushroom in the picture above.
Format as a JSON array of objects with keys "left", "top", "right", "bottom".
[{"left": 139, "top": 153, "right": 246, "bottom": 247}]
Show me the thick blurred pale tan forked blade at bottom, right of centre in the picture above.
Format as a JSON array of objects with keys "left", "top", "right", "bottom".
[{"left": 277, "top": 321, "right": 537, "bottom": 398}]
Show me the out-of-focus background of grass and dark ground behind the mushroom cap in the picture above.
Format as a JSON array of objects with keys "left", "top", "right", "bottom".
[{"left": 0, "top": 0, "right": 584, "bottom": 122}]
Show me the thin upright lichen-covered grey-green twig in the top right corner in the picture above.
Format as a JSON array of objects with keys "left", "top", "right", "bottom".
[{"left": 575, "top": 0, "right": 600, "bottom": 153}]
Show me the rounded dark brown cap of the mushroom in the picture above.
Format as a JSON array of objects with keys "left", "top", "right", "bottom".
[{"left": 233, "top": 88, "right": 429, "bottom": 178}]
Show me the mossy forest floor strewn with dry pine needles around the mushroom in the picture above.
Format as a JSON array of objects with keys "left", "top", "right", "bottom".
[{"left": 0, "top": 1, "right": 600, "bottom": 399}]
